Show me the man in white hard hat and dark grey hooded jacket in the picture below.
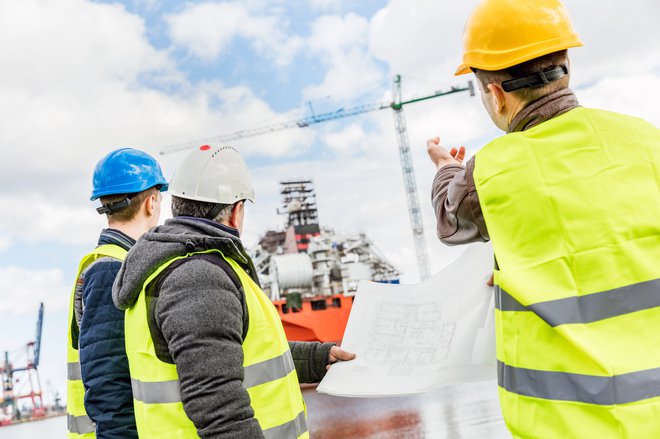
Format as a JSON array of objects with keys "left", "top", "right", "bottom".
[{"left": 113, "top": 145, "right": 354, "bottom": 439}]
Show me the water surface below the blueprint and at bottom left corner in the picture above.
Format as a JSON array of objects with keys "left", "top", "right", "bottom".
[{"left": 0, "top": 381, "right": 511, "bottom": 439}]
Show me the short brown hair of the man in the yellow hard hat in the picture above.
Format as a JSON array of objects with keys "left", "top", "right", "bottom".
[{"left": 474, "top": 50, "right": 569, "bottom": 104}]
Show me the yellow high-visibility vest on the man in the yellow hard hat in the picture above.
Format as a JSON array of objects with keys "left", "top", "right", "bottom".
[{"left": 474, "top": 108, "right": 660, "bottom": 439}]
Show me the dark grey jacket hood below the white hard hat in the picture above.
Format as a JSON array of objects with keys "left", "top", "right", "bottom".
[{"left": 112, "top": 217, "right": 251, "bottom": 310}]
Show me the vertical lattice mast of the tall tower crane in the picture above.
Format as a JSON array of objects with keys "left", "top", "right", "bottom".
[{"left": 392, "top": 75, "right": 430, "bottom": 280}]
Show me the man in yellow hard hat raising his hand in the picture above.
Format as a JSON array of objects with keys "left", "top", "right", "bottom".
[{"left": 427, "top": 0, "right": 660, "bottom": 439}]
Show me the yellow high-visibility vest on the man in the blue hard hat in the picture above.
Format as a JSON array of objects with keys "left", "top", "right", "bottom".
[{"left": 66, "top": 244, "right": 127, "bottom": 439}]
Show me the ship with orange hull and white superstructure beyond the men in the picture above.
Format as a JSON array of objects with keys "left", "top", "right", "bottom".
[{"left": 251, "top": 180, "right": 400, "bottom": 342}]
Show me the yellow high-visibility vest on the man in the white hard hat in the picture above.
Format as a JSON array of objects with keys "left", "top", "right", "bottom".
[{"left": 125, "top": 250, "right": 309, "bottom": 439}]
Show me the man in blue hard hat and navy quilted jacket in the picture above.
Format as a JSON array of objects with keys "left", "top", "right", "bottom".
[{"left": 67, "top": 148, "right": 168, "bottom": 439}]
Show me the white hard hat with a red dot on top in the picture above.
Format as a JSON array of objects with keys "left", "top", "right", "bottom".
[{"left": 169, "top": 145, "right": 254, "bottom": 204}]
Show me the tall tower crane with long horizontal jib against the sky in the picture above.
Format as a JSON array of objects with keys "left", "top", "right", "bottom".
[{"left": 161, "top": 75, "right": 474, "bottom": 280}]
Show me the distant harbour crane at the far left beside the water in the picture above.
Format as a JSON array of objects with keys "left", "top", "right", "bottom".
[{"left": 0, "top": 303, "right": 45, "bottom": 419}]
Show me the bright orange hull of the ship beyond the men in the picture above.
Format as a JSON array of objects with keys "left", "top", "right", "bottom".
[{"left": 273, "top": 294, "right": 353, "bottom": 343}]
